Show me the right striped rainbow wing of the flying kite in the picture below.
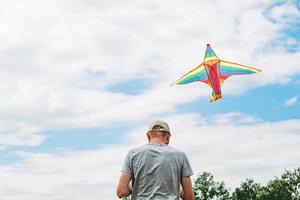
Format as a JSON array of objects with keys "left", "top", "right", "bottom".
[{"left": 220, "top": 60, "right": 261, "bottom": 84}]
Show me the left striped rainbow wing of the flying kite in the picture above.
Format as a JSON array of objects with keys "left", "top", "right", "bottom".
[{"left": 171, "top": 63, "right": 211, "bottom": 86}]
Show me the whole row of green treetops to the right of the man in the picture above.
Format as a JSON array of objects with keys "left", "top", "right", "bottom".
[{"left": 193, "top": 167, "right": 300, "bottom": 200}]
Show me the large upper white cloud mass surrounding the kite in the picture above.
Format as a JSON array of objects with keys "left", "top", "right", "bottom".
[{"left": 0, "top": 0, "right": 300, "bottom": 148}]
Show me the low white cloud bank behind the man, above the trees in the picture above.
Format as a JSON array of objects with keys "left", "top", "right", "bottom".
[{"left": 0, "top": 113, "right": 300, "bottom": 200}]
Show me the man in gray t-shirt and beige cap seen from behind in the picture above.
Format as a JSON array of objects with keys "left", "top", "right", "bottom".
[{"left": 117, "top": 120, "right": 194, "bottom": 200}]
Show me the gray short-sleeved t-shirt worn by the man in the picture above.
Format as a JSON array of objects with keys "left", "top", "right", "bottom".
[{"left": 122, "top": 144, "right": 193, "bottom": 200}]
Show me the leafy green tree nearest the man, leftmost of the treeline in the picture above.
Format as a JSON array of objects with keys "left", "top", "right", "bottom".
[{"left": 193, "top": 172, "right": 230, "bottom": 200}]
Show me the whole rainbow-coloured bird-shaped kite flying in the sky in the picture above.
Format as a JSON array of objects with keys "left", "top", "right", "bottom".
[{"left": 171, "top": 44, "right": 261, "bottom": 102}]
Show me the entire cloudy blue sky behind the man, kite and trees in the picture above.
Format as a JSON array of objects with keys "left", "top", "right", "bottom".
[{"left": 0, "top": 0, "right": 300, "bottom": 200}]
